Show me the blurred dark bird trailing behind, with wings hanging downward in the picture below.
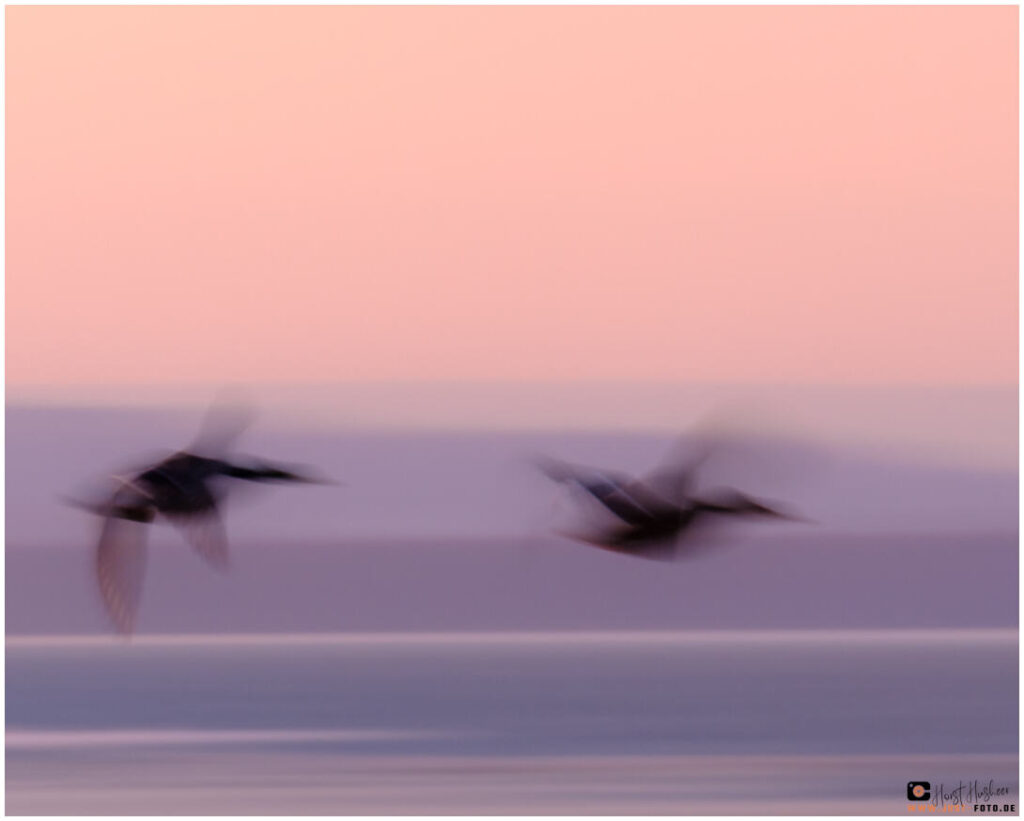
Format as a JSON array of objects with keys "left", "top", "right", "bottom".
[{"left": 72, "top": 401, "right": 325, "bottom": 635}]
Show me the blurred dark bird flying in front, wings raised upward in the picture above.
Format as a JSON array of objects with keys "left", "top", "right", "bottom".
[{"left": 539, "top": 438, "right": 797, "bottom": 560}]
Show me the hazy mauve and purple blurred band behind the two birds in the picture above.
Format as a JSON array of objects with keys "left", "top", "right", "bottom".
[{"left": 7, "top": 385, "right": 1017, "bottom": 634}]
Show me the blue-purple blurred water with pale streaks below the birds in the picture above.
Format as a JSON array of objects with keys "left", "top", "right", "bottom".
[{"left": 7, "top": 631, "right": 1018, "bottom": 814}]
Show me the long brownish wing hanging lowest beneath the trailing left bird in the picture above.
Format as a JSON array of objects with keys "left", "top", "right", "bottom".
[{"left": 96, "top": 515, "right": 146, "bottom": 635}]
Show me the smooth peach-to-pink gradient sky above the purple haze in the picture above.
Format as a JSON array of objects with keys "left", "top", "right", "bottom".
[{"left": 6, "top": 6, "right": 1018, "bottom": 388}]
